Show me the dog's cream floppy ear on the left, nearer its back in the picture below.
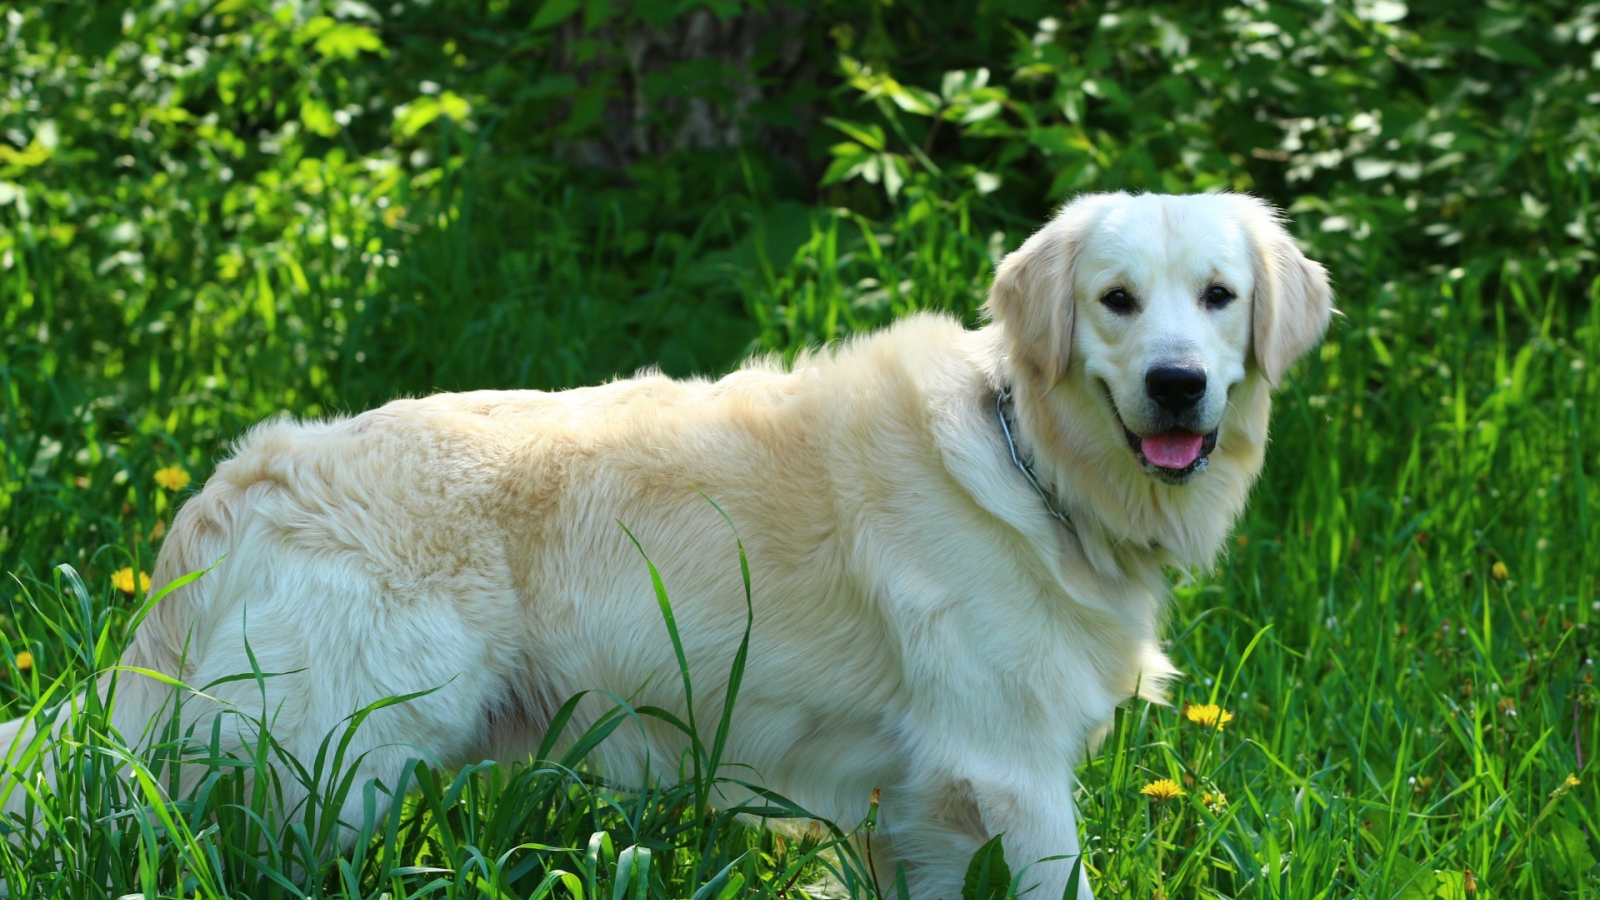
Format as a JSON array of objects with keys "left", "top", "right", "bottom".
[{"left": 984, "top": 199, "right": 1093, "bottom": 384}]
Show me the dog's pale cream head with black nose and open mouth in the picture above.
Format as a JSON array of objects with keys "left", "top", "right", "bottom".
[{"left": 987, "top": 194, "right": 1333, "bottom": 485}]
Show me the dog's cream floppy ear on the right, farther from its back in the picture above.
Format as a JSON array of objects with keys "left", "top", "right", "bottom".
[{"left": 1243, "top": 197, "right": 1333, "bottom": 384}]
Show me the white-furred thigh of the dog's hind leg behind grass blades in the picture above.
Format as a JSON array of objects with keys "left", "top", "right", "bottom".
[{"left": 151, "top": 536, "right": 504, "bottom": 842}]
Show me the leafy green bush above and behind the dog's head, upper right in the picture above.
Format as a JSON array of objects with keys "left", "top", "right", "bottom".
[{"left": 827, "top": 0, "right": 1600, "bottom": 291}]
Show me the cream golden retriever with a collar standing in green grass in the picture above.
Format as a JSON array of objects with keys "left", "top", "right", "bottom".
[{"left": 0, "top": 194, "right": 1333, "bottom": 900}]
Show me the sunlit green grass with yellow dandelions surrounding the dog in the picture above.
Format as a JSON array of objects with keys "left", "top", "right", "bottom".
[{"left": 0, "top": 171, "right": 1600, "bottom": 897}]
